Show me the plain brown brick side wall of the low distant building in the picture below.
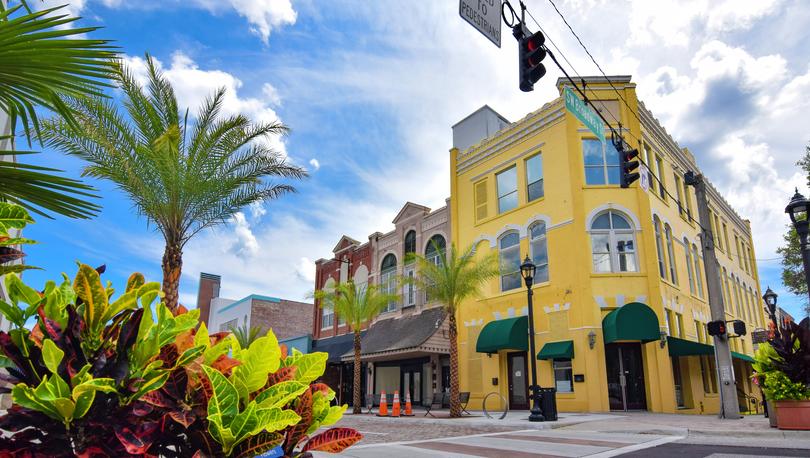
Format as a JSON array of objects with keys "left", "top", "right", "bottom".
[{"left": 250, "top": 299, "right": 313, "bottom": 340}]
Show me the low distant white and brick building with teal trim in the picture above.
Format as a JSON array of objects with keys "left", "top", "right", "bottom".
[{"left": 197, "top": 272, "right": 313, "bottom": 339}]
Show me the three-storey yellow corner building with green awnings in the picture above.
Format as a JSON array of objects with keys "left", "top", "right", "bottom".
[{"left": 450, "top": 76, "right": 765, "bottom": 413}]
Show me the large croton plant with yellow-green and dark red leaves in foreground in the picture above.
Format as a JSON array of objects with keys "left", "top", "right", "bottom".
[{"left": 0, "top": 208, "right": 362, "bottom": 457}]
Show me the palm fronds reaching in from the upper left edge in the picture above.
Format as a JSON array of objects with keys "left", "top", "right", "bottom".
[{"left": 0, "top": 0, "right": 117, "bottom": 218}]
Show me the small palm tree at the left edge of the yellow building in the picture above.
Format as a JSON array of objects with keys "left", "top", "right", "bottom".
[{"left": 406, "top": 242, "right": 498, "bottom": 417}]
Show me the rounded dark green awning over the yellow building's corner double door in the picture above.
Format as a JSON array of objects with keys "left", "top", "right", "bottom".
[{"left": 602, "top": 302, "right": 661, "bottom": 343}]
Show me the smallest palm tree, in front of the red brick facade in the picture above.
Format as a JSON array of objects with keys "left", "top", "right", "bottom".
[{"left": 314, "top": 280, "right": 399, "bottom": 413}]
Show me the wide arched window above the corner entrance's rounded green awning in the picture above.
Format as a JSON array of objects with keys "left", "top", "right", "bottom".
[{"left": 590, "top": 210, "right": 638, "bottom": 272}]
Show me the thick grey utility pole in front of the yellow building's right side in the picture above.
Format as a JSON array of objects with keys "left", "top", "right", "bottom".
[{"left": 684, "top": 171, "right": 742, "bottom": 420}]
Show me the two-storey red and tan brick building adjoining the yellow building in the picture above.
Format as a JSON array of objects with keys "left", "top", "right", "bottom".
[{"left": 312, "top": 202, "right": 450, "bottom": 404}]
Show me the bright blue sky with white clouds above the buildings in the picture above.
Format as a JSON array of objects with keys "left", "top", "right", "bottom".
[{"left": 17, "top": 0, "right": 810, "bottom": 317}]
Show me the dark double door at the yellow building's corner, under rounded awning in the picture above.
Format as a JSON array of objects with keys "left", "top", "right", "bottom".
[{"left": 605, "top": 343, "right": 647, "bottom": 410}]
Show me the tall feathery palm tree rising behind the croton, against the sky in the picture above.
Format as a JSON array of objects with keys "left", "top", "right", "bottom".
[{"left": 43, "top": 55, "right": 306, "bottom": 310}]
